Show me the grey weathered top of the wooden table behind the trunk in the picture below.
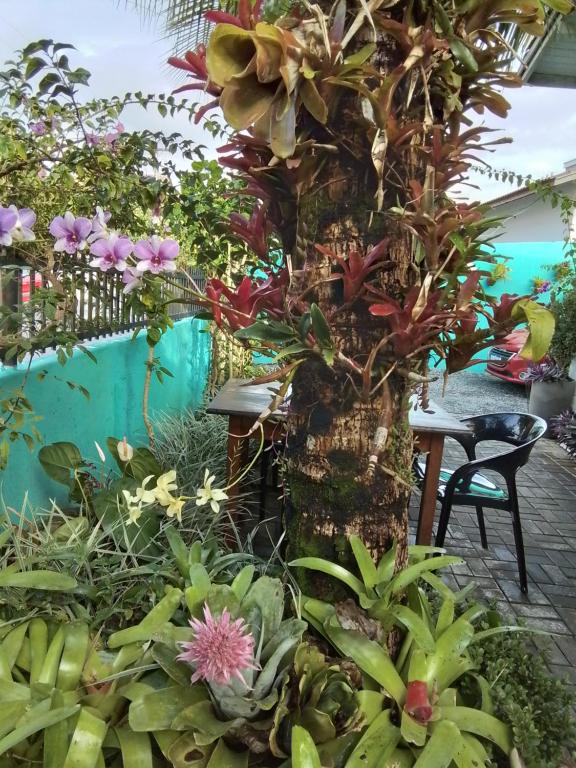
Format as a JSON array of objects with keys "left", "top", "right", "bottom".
[{"left": 206, "top": 379, "right": 468, "bottom": 435}]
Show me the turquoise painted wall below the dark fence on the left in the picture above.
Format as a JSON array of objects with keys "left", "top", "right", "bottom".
[{"left": 0, "top": 319, "right": 210, "bottom": 508}]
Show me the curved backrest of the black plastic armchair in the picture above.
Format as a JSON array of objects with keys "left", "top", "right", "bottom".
[{"left": 462, "top": 412, "right": 548, "bottom": 469}]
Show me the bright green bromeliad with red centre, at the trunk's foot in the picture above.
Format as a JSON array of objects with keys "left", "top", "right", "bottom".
[{"left": 292, "top": 541, "right": 514, "bottom": 768}]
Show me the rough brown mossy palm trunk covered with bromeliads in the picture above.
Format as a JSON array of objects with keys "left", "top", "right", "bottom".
[{"left": 286, "top": 94, "right": 418, "bottom": 597}]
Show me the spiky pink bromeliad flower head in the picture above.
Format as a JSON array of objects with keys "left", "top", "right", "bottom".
[{"left": 178, "top": 605, "right": 256, "bottom": 685}]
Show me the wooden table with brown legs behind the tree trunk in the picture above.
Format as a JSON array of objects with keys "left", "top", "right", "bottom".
[{"left": 207, "top": 379, "right": 467, "bottom": 544}]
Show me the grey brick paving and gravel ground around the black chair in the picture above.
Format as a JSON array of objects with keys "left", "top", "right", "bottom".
[{"left": 410, "top": 373, "right": 576, "bottom": 686}]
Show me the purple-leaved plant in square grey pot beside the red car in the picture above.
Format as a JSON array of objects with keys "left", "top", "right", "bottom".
[{"left": 525, "top": 357, "right": 576, "bottom": 422}]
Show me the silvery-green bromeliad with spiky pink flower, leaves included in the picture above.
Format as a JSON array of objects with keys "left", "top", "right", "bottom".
[{"left": 129, "top": 566, "right": 306, "bottom": 764}]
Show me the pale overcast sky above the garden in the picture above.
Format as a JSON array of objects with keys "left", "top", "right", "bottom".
[{"left": 0, "top": 0, "right": 576, "bottom": 199}]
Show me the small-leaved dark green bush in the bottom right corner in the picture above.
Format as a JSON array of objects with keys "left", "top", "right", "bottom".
[{"left": 473, "top": 634, "right": 576, "bottom": 768}]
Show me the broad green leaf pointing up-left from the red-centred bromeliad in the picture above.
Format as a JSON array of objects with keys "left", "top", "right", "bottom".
[{"left": 324, "top": 624, "right": 406, "bottom": 706}]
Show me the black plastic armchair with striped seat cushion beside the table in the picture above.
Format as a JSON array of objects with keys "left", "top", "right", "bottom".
[{"left": 414, "top": 413, "right": 547, "bottom": 594}]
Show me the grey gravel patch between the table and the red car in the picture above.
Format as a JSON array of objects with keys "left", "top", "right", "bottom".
[{"left": 430, "top": 371, "right": 528, "bottom": 417}]
